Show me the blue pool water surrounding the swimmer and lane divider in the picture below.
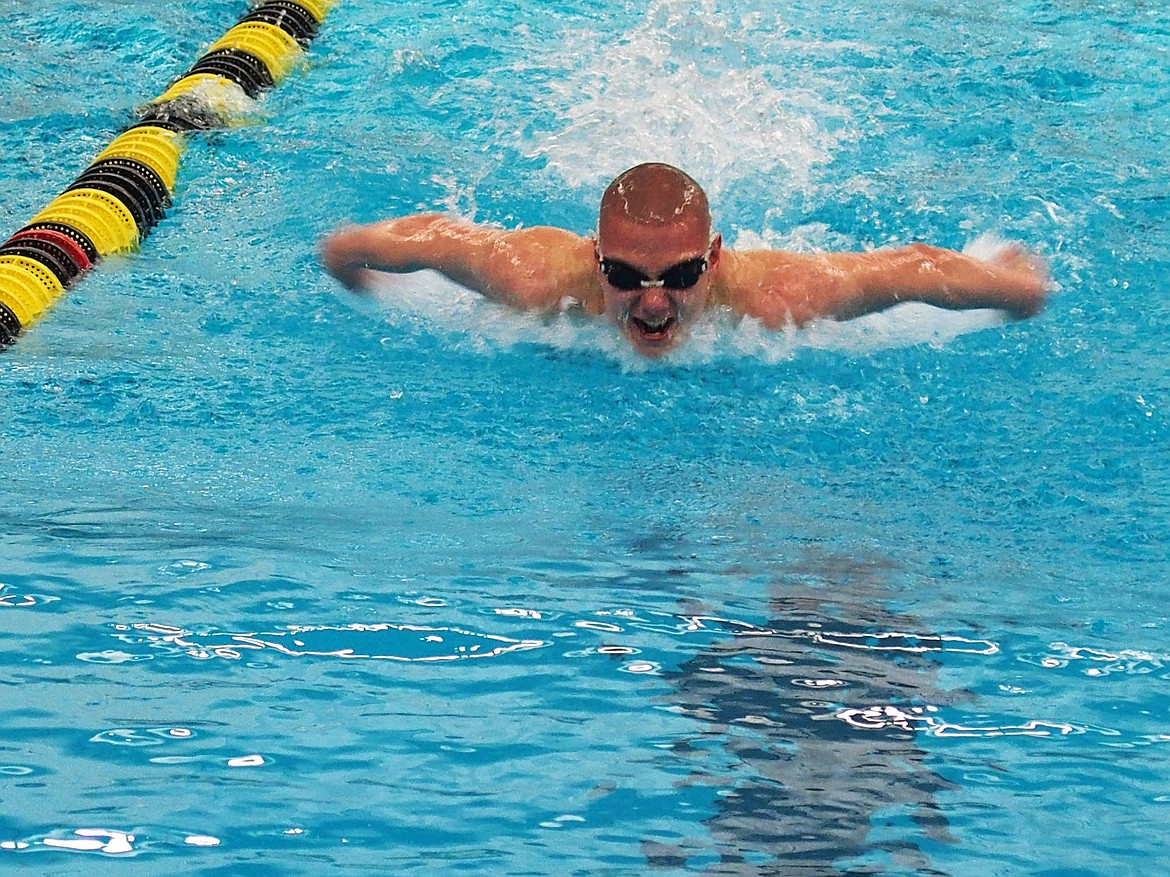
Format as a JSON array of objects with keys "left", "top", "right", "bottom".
[{"left": 0, "top": 0, "right": 1170, "bottom": 877}]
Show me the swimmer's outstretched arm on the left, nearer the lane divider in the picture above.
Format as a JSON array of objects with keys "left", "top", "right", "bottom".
[{"left": 321, "top": 213, "right": 591, "bottom": 309}]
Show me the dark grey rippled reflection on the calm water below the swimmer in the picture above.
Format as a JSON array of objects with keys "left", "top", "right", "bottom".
[{"left": 645, "top": 565, "right": 959, "bottom": 875}]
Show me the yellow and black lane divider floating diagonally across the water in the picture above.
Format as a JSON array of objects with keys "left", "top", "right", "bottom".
[{"left": 0, "top": 0, "right": 336, "bottom": 347}]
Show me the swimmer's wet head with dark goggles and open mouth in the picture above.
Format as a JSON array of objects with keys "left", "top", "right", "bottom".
[{"left": 597, "top": 164, "right": 721, "bottom": 357}]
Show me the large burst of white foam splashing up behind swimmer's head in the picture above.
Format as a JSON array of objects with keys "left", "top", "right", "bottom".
[{"left": 525, "top": 0, "right": 856, "bottom": 200}]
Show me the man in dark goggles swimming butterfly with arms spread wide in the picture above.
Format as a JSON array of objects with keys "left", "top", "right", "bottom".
[{"left": 322, "top": 164, "right": 1049, "bottom": 357}]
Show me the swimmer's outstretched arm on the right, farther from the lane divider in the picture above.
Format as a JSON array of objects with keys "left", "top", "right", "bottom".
[{"left": 741, "top": 243, "right": 1051, "bottom": 327}]
